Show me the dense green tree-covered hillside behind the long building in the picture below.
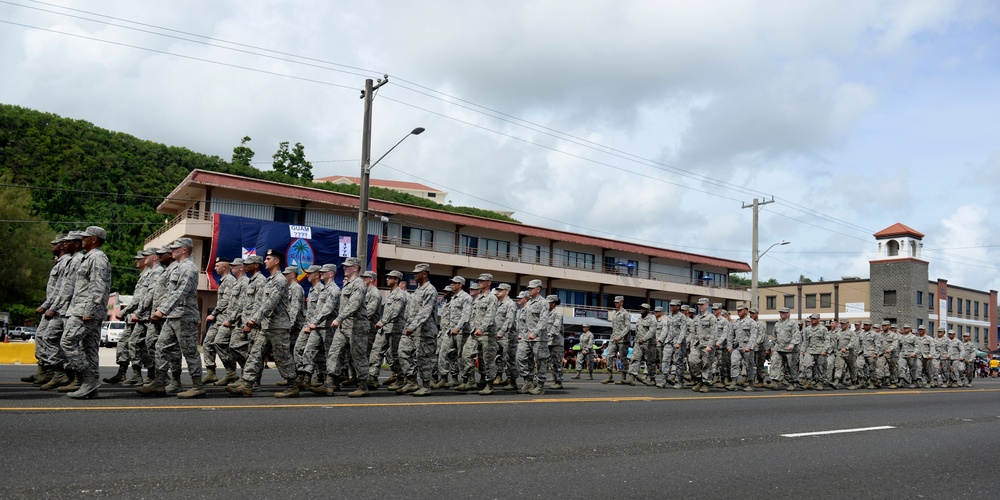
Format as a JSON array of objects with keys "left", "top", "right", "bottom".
[{"left": 0, "top": 104, "right": 517, "bottom": 309}]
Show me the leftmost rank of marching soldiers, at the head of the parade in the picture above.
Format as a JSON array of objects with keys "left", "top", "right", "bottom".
[{"left": 21, "top": 226, "right": 111, "bottom": 399}]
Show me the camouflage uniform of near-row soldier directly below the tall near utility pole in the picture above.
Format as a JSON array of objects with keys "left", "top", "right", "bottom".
[{"left": 326, "top": 275, "right": 368, "bottom": 387}]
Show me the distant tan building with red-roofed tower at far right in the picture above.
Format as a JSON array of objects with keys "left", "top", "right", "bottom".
[{"left": 759, "top": 223, "right": 998, "bottom": 350}]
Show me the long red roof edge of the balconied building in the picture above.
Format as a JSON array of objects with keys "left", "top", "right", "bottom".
[{"left": 158, "top": 170, "right": 750, "bottom": 272}]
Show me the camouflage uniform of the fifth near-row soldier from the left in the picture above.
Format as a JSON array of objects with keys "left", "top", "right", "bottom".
[{"left": 399, "top": 282, "right": 438, "bottom": 387}]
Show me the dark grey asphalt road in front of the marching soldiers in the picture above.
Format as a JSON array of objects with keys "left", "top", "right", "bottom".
[{"left": 0, "top": 366, "right": 1000, "bottom": 499}]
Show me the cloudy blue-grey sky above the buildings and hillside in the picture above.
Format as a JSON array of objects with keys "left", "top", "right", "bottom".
[{"left": 0, "top": 0, "right": 1000, "bottom": 289}]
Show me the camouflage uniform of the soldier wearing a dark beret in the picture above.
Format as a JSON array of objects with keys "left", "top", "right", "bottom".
[{"left": 241, "top": 272, "right": 295, "bottom": 385}]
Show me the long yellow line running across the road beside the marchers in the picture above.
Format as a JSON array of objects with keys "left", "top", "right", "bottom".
[{"left": 0, "top": 389, "right": 1000, "bottom": 413}]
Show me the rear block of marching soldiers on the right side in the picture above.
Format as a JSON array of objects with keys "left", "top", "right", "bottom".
[{"left": 588, "top": 296, "right": 977, "bottom": 392}]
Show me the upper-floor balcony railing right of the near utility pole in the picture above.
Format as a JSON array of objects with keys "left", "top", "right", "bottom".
[{"left": 383, "top": 237, "right": 746, "bottom": 290}]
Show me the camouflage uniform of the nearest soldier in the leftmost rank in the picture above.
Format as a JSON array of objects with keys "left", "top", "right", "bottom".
[{"left": 60, "top": 248, "right": 111, "bottom": 380}]
